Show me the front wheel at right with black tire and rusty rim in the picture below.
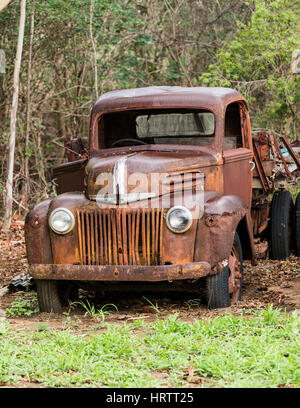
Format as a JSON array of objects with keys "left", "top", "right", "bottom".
[{"left": 207, "top": 232, "right": 243, "bottom": 309}]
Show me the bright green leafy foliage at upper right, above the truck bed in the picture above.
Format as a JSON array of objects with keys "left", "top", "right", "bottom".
[{"left": 200, "top": 0, "right": 300, "bottom": 136}]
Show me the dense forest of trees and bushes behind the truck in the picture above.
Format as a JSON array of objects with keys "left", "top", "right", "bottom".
[{"left": 0, "top": 0, "right": 300, "bottom": 219}]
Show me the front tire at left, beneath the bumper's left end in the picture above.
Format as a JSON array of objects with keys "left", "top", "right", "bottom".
[{"left": 35, "top": 279, "right": 62, "bottom": 313}]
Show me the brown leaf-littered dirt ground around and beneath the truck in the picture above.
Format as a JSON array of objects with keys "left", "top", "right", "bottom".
[{"left": 0, "top": 225, "right": 300, "bottom": 329}]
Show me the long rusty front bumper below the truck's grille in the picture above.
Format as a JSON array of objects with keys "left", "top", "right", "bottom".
[{"left": 29, "top": 262, "right": 211, "bottom": 282}]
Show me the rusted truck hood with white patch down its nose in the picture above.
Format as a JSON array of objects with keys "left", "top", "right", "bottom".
[{"left": 86, "top": 149, "right": 220, "bottom": 204}]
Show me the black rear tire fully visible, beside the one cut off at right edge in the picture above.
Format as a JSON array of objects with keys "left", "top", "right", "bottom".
[{"left": 270, "top": 191, "right": 294, "bottom": 260}]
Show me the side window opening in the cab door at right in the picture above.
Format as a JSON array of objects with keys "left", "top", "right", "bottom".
[{"left": 223, "top": 102, "right": 243, "bottom": 150}]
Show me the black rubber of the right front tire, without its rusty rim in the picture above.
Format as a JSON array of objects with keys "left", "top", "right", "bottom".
[{"left": 206, "top": 232, "right": 243, "bottom": 309}]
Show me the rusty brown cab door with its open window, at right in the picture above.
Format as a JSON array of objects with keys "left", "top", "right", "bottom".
[{"left": 223, "top": 102, "right": 253, "bottom": 209}]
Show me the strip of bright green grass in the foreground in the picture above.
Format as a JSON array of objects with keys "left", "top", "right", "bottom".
[{"left": 0, "top": 306, "right": 300, "bottom": 388}]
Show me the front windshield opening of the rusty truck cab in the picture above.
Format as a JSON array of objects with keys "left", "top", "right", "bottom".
[{"left": 99, "top": 110, "right": 215, "bottom": 148}]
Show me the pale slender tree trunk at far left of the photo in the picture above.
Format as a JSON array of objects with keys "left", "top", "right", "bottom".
[{"left": 3, "top": 0, "right": 26, "bottom": 231}]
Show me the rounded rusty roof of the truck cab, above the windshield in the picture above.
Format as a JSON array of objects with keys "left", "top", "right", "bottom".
[{"left": 91, "top": 86, "right": 244, "bottom": 114}]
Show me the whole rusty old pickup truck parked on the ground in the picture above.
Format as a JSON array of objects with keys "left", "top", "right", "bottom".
[{"left": 25, "top": 86, "right": 300, "bottom": 313}]
